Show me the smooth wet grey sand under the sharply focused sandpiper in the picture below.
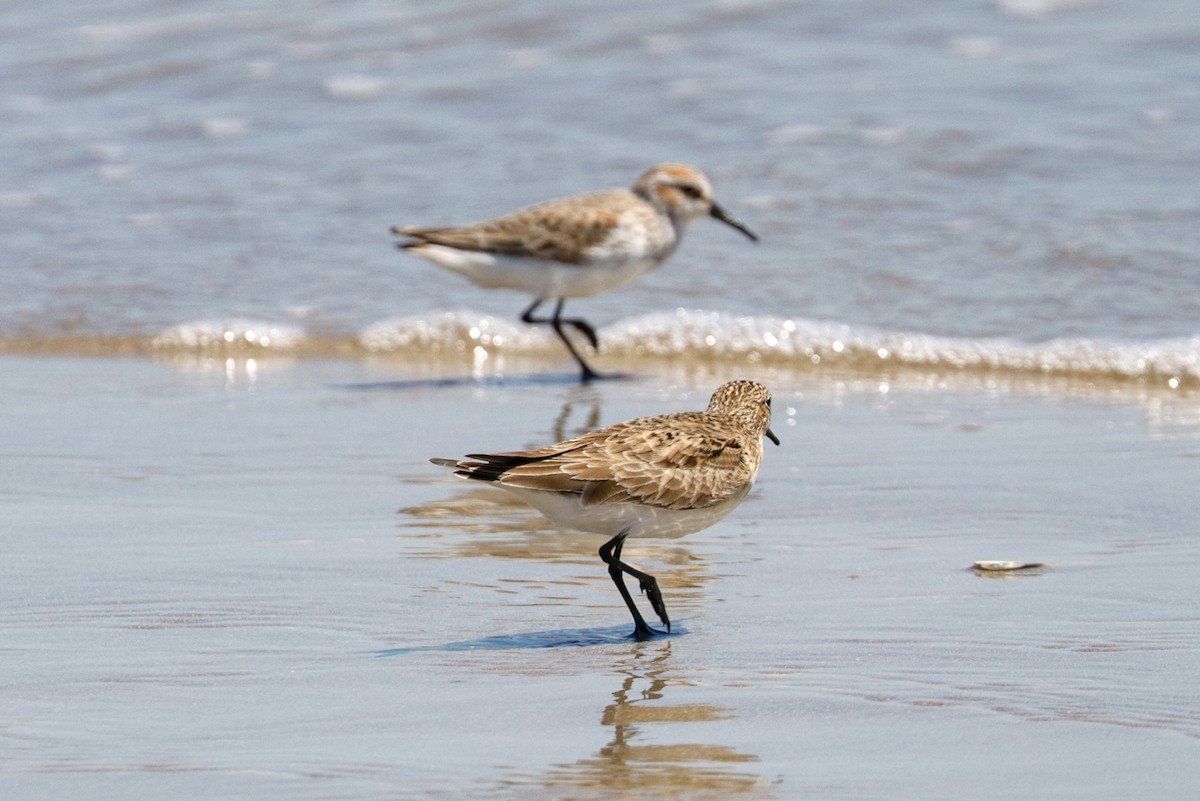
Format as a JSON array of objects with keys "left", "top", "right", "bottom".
[{"left": 0, "top": 359, "right": 1200, "bottom": 801}]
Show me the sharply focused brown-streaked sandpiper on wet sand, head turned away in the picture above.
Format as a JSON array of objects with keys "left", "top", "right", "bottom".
[{"left": 431, "top": 380, "right": 779, "bottom": 639}]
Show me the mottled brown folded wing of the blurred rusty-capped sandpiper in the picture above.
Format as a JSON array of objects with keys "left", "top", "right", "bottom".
[{"left": 398, "top": 192, "right": 618, "bottom": 264}]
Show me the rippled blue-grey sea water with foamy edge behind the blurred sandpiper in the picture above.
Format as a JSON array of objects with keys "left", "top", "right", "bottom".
[{"left": 0, "top": 0, "right": 1200, "bottom": 385}]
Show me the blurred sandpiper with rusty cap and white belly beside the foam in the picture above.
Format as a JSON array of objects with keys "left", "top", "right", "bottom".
[{"left": 391, "top": 164, "right": 758, "bottom": 381}]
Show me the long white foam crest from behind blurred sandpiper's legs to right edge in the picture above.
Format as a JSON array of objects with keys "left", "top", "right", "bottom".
[{"left": 359, "top": 309, "right": 1200, "bottom": 389}]
